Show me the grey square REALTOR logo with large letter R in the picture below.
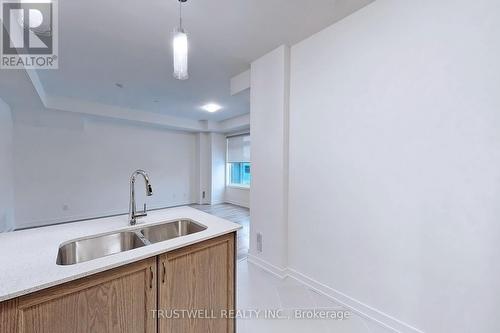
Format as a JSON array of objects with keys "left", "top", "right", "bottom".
[{"left": 0, "top": 0, "right": 58, "bottom": 69}]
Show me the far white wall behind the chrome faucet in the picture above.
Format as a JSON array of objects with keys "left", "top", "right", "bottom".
[{"left": 13, "top": 110, "right": 197, "bottom": 228}]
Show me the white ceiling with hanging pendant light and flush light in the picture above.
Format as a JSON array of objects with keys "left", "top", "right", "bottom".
[{"left": 0, "top": 0, "right": 373, "bottom": 121}]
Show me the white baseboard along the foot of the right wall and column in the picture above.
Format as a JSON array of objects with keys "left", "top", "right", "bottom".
[{"left": 244, "top": 255, "right": 424, "bottom": 333}]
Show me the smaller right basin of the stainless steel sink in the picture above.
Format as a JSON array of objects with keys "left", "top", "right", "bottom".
[{"left": 141, "top": 220, "right": 207, "bottom": 243}]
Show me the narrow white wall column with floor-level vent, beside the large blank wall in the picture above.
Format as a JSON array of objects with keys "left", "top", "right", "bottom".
[{"left": 250, "top": 46, "right": 290, "bottom": 269}]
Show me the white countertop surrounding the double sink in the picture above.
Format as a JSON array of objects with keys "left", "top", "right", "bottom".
[{"left": 0, "top": 206, "right": 241, "bottom": 302}]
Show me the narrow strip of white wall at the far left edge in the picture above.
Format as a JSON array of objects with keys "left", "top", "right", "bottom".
[{"left": 0, "top": 99, "right": 14, "bottom": 232}]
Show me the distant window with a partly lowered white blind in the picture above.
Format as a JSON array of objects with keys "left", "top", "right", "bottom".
[{"left": 226, "top": 134, "right": 252, "bottom": 188}]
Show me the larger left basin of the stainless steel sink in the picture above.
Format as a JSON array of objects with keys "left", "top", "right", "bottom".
[{"left": 57, "top": 232, "right": 145, "bottom": 265}]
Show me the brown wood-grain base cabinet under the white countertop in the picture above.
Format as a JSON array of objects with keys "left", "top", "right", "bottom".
[{"left": 0, "top": 234, "right": 235, "bottom": 333}]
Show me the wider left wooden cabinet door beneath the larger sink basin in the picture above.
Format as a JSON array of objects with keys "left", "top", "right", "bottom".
[{"left": 4, "top": 258, "right": 157, "bottom": 333}]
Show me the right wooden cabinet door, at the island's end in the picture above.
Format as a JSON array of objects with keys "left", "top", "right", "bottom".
[{"left": 158, "top": 233, "right": 235, "bottom": 333}]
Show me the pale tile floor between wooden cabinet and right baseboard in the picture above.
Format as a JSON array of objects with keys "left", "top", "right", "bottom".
[{"left": 237, "top": 260, "right": 392, "bottom": 333}]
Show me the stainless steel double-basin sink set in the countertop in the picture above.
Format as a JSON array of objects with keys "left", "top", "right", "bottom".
[{"left": 56, "top": 219, "right": 207, "bottom": 265}]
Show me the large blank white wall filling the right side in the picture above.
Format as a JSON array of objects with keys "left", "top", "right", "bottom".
[{"left": 288, "top": 0, "right": 500, "bottom": 333}]
